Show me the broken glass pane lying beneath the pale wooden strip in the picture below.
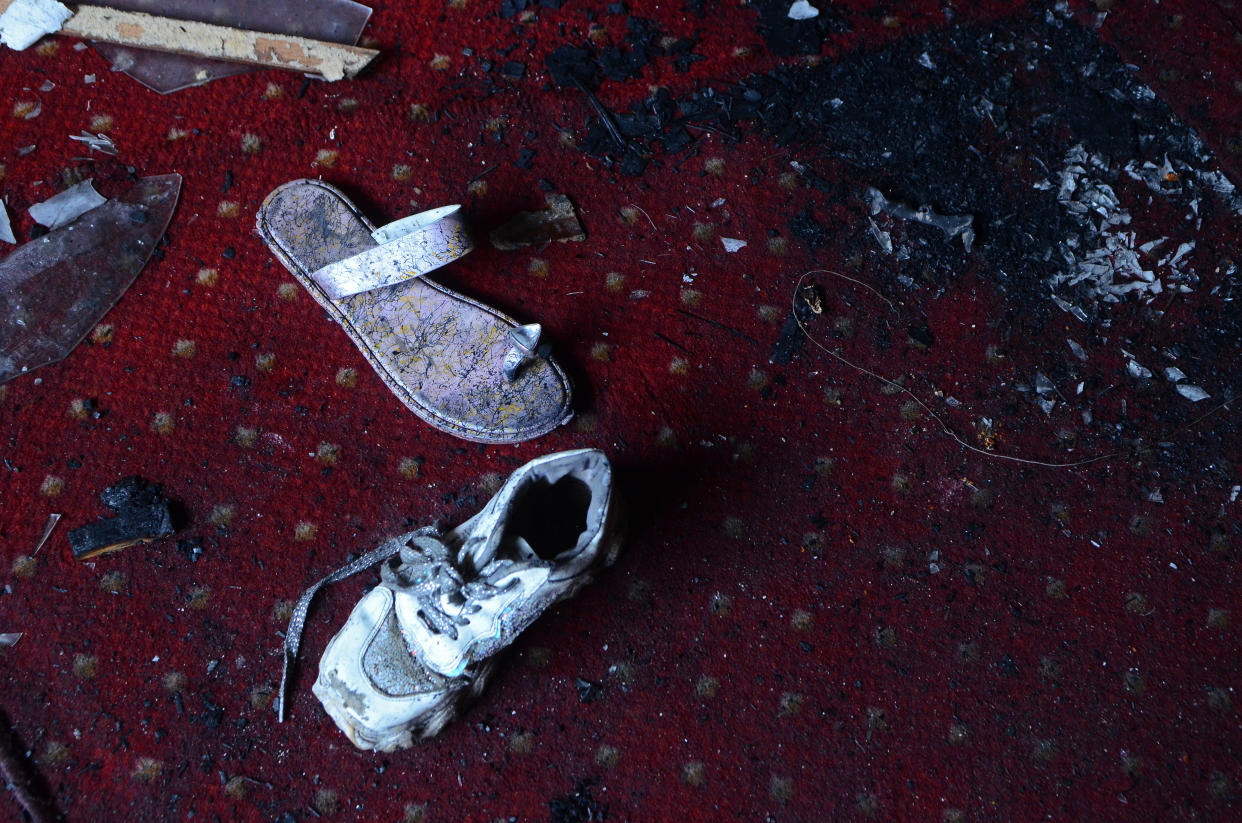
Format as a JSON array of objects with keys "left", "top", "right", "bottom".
[{"left": 87, "top": 0, "right": 371, "bottom": 94}]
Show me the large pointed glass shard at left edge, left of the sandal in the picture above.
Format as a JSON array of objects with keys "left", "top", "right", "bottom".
[{"left": 0, "top": 174, "right": 181, "bottom": 384}]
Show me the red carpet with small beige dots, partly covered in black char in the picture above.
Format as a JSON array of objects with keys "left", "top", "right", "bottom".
[{"left": 0, "top": 0, "right": 1242, "bottom": 823}]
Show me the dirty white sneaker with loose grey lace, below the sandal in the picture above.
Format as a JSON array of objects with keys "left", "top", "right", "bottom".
[{"left": 277, "top": 449, "right": 620, "bottom": 751}]
